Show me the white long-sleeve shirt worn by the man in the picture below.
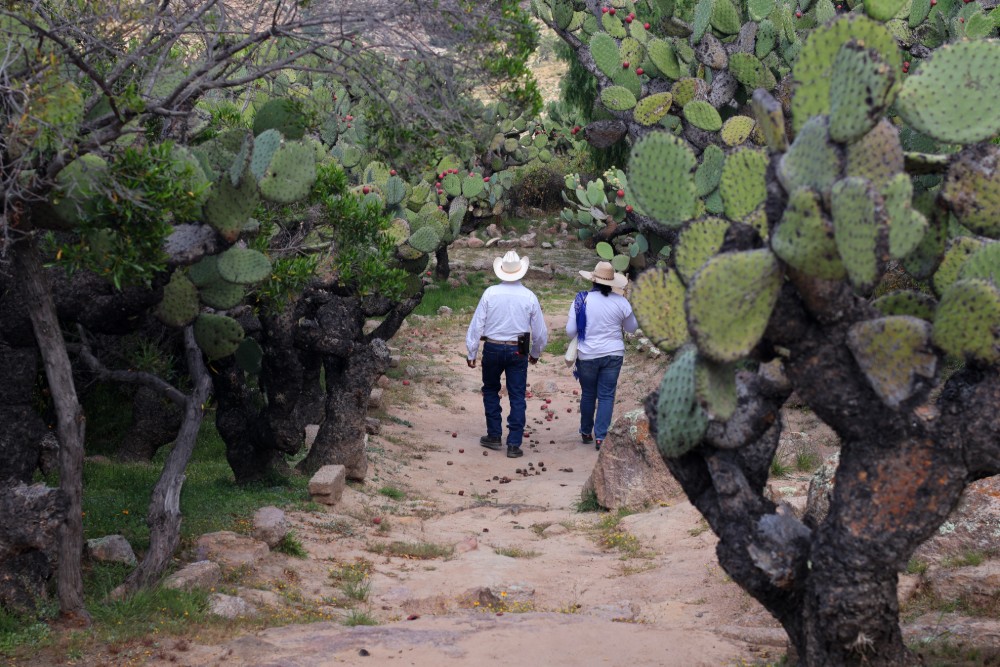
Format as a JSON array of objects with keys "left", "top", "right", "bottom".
[{"left": 465, "top": 281, "right": 549, "bottom": 359}]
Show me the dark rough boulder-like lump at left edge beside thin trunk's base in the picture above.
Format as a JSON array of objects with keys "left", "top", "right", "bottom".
[{"left": 0, "top": 479, "right": 68, "bottom": 613}]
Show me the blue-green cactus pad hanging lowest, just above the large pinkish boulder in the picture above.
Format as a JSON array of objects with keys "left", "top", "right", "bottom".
[{"left": 656, "top": 344, "right": 708, "bottom": 459}]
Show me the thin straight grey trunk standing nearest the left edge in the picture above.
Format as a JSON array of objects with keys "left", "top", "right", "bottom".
[{"left": 14, "top": 236, "right": 90, "bottom": 625}]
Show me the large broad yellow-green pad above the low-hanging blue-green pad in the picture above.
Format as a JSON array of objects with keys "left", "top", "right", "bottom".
[{"left": 686, "top": 250, "right": 782, "bottom": 361}]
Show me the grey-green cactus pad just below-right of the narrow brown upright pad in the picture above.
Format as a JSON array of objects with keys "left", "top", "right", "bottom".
[{"left": 778, "top": 116, "right": 842, "bottom": 199}]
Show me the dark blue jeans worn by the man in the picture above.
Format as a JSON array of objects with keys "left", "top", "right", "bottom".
[{"left": 482, "top": 342, "right": 528, "bottom": 447}]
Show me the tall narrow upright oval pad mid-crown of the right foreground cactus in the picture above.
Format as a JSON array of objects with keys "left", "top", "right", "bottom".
[{"left": 830, "top": 177, "right": 888, "bottom": 293}]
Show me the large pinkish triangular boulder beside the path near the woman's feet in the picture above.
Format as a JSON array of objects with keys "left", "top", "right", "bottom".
[{"left": 583, "top": 409, "right": 681, "bottom": 509}]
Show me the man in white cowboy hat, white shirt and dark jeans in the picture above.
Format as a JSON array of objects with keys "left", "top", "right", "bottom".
[{"left": 465, "top": 250, "right": 549, "bottom": 458}]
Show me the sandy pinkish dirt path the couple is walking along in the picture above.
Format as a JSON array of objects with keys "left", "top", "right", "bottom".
[{"left": 143, "top": 296, "right": 812, "bottom": 667}]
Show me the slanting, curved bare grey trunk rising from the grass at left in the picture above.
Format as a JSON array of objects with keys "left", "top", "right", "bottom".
[{"left": 111, "top": 326, "right": 212, "bottom": 598}]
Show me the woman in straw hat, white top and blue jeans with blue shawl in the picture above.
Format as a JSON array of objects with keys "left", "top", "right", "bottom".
[{"left": 566, "top": 262, "right": 639, "bottom": 450}]
